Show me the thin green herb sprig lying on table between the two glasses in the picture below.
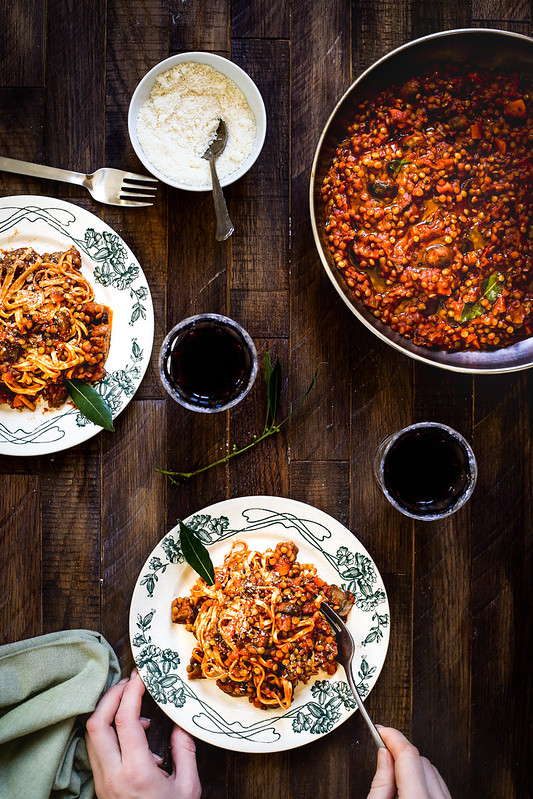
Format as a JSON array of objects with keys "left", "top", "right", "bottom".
[{"left": 157, "top": 350, "right": 321, "bottom": 485}]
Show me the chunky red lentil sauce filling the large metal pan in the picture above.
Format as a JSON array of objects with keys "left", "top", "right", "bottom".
[{"left": 321, "top": 65, "right": 533, "bottom": 350}]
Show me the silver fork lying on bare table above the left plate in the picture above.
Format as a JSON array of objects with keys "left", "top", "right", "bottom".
[{"left": 0, "top": 156, "right": 157, "bottom": 208}]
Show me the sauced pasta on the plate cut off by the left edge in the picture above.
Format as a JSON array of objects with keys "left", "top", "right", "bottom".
[{"left": 0, "top": 247, "right": 111, "bottom": 410}]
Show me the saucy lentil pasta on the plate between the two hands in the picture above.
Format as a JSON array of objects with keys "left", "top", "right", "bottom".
[{"left": 172, "top": 541, "right": 354, "bottom": 709}]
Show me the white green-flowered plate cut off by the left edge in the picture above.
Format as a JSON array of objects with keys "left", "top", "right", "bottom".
[{"left": 0, "top": 196, "right": 154, "bottom": 456}]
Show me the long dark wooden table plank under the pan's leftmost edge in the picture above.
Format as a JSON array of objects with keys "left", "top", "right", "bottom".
[{"left": 291, "top": 2, "right": 351, "bottom": 460}]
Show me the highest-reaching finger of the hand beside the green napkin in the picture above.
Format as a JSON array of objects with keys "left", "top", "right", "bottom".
[{"left": 115, "top": 669, "right": 153, "bottom": 767}]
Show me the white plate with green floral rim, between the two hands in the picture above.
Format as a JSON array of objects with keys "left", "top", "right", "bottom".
[{"left": 130, "top": 496, "right": 390, "bottom": 752}]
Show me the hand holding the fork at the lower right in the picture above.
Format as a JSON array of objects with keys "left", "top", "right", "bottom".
[{"left": 368, "top": 727, "right": 451, "bottom": 799}]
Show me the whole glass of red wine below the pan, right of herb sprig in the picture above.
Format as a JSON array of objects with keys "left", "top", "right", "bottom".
[{"left": 374, "top": 422, "right": 477, "bottom": 521}]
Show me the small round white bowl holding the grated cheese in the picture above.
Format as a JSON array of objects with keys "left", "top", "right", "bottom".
[{"left": 128, "top": 52, "right": 266, "bottom": 191}]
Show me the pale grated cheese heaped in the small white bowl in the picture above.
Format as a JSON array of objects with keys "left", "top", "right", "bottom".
[{"left": 137, "top": 61, "right": 256, "bottom": 187}]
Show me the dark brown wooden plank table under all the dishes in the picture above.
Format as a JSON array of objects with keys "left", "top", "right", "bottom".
[{"left": 0, "top": 0, "right": 533, "bottom": 799}]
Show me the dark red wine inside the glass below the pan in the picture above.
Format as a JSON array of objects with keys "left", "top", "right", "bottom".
[{"left": 383, "top": 427, "right": 471, "bottom": 516}]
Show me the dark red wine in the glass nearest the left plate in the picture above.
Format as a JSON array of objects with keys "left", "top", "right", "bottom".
[{"left": 163, "top": 321, "right": 251, "bottom": 408}]
